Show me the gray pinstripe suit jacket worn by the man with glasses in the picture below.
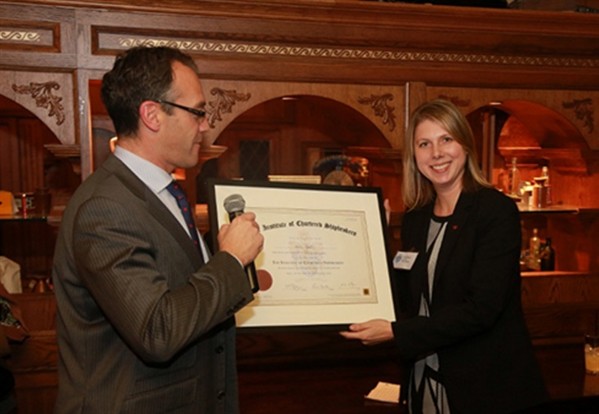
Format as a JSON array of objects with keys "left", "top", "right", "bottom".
[{"left": 53, "top": 156, "right": 253, "bottom": 414}]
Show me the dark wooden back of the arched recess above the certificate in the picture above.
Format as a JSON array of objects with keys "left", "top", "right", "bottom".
[{"left": 207, "top": 90, "right": 401, "bottom": 207}]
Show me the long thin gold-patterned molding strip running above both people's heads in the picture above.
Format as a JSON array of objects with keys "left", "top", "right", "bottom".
[{"left": 117, "top": 37, "right": 599, "bottom": 68}]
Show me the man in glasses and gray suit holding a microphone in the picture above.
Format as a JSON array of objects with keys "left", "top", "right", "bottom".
[{"left": 53, "top": 47, "right": 263, "bottom": 414}]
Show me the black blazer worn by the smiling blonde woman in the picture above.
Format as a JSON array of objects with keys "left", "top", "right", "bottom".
[{"left": 393, "top": 188, "right": 548, "bottom": 414}]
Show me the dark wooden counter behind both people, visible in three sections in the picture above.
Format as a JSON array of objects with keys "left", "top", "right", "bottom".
[{"left": 9, "top": 274, "right": 599, "bottom": 414}]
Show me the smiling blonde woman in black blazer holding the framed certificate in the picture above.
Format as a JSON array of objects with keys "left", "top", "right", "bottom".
[{"left": 342, "top": 100, "right": 548, "bottom": 414}]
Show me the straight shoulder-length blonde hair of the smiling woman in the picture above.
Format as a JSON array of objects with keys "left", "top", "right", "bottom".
[{"left": 402, "top": 99, "right": 491, "bottom": 210}]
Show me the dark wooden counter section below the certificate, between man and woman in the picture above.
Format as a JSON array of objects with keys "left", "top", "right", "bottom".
[{"left": 238, "top": 327, "right": 402, "bottom": 414}]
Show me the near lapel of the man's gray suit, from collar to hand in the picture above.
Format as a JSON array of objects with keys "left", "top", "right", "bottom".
[{"left": 102, "top": 156, "right": 203, "bottom": 267}]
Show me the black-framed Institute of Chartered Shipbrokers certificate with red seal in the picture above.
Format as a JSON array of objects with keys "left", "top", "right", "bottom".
[{"left": 208, "top": 179, "right": 395, "bottom": 327}]
